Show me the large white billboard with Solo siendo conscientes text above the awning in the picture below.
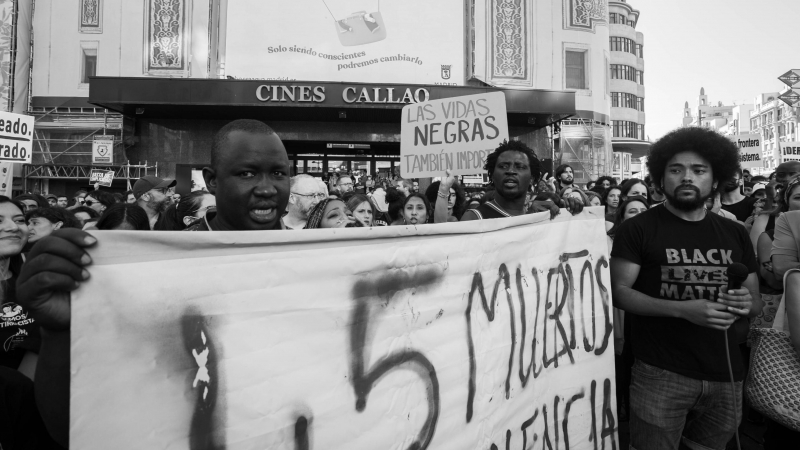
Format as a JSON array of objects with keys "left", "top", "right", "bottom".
[{"left": 225, "top": 0, "right": 465, "bottom": 86}]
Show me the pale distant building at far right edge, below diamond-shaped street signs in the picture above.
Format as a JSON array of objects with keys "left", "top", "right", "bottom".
[{"left": 750, "top": 90, "right": 800, "bottom": 172}]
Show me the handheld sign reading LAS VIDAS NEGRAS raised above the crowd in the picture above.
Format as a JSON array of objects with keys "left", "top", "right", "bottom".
[{"left": 400, "top": 92, "right": 508, "bottom": 178}]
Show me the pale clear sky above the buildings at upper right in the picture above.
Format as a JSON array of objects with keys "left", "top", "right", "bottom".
[{"left": 628, "top": 0, "right": 800, "bottom": 141}]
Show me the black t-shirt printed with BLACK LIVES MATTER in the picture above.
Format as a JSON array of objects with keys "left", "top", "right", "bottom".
[{"left": 611, "top": 205, "right": 757, "bottom": 381}]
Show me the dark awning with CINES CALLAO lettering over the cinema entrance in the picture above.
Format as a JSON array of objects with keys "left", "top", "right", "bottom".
[{"left": 89, "top": 77, "right": 575, "bottom": 128}]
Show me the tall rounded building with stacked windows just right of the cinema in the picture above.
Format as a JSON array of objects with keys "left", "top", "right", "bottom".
[{"left": 608, "top": 0, "right": 650, "bottom": 179}]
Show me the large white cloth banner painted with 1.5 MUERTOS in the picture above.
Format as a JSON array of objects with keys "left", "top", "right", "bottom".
[{"left": 70, "top": 208, "right": 618, "bottom": 450}]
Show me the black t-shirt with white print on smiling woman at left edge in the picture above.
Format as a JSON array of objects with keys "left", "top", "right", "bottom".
[{"left": 0, "top": 255, "right": 42, "bottom": 369}]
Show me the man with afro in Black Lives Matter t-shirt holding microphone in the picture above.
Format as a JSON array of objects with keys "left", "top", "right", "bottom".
[{"left": 611, "top": 127, "right": 762, "bottom": 450}]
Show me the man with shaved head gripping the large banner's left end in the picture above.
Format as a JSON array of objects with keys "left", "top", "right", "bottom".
[{"left": 17, "top": 120, "right": 289, "bottom": 446}]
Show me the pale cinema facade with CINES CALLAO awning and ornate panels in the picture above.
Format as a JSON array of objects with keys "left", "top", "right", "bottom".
[{"left": 17, "top": 0, "right": 613, "bottom": 194}]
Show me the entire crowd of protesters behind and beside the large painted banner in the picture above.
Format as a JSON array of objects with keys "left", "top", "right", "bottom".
[{"left": 0, "top": 120, "right": 800, "bottom": 449}]
